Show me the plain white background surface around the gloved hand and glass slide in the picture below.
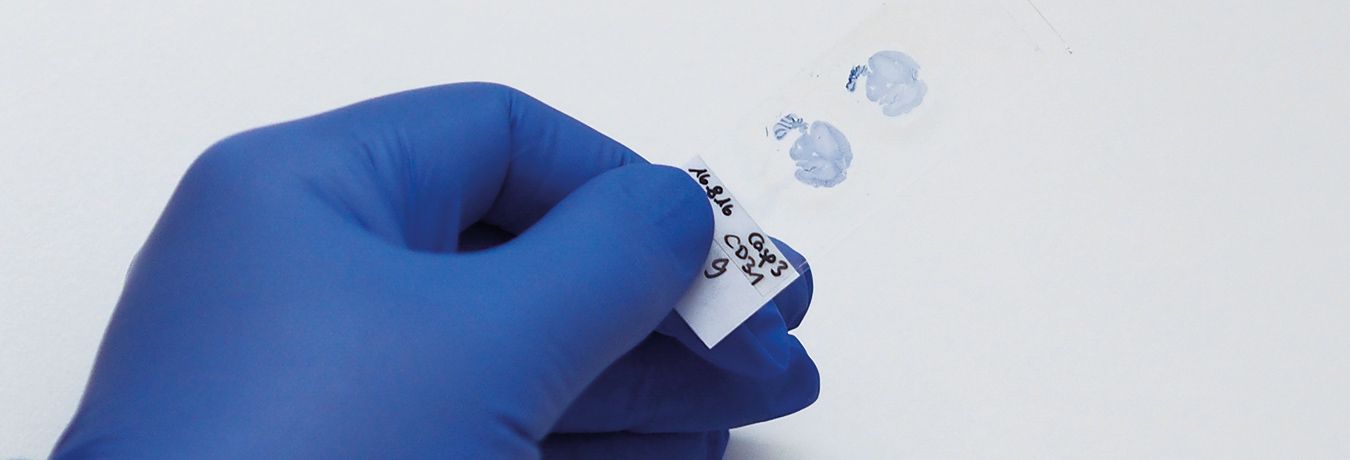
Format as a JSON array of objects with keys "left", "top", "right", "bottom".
[{"left": 0, "top": 0, "right": 1350, "bottom": 459}]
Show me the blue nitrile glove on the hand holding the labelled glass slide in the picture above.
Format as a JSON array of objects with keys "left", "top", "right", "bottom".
[{"left": 54, "top": 84, "right": 818, "bottom": 459}]
